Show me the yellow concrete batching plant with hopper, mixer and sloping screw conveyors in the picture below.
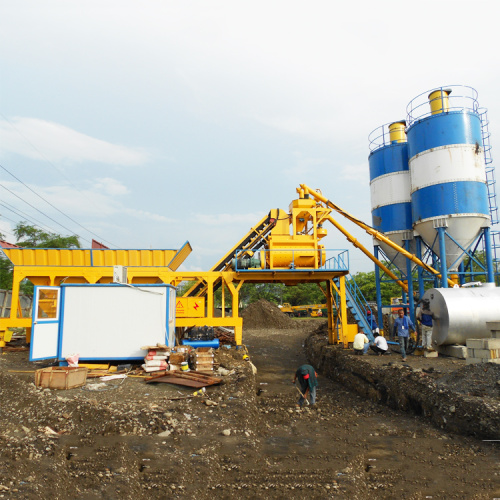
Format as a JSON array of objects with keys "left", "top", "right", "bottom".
[{"left": 0, "top": 184, "right": 446, "bottom": 347}]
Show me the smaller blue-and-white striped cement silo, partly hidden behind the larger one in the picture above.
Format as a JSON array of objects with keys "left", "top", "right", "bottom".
[{"left": 368, "top": 121, "right": 415, "bottom": 275}]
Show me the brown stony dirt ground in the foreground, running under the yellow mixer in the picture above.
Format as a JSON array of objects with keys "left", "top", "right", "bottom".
[{"left": 0, "top": 319, "right": 500, "bottom": 499}]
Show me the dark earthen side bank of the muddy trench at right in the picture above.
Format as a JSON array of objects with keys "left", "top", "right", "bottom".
[{"left": 305, "top": 335, "right": 500, "bottom": 440}]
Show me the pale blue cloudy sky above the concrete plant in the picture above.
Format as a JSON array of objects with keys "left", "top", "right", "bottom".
[{"left": 0, "top": 0, "right": 500, "bottom": 273}]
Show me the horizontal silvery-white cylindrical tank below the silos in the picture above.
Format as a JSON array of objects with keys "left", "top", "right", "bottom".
[{"left": 422, "top": 284, "right": 500, "bottom": 346}]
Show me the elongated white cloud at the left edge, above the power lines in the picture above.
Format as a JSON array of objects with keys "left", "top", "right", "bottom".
[{"left": 0, "top": 117, "right": 149, "bottom": 166}]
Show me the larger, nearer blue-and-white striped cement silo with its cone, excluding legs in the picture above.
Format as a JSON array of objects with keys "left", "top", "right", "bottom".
[{"left": 407, "top": 86, "right": 490, "bottom": 271}]
